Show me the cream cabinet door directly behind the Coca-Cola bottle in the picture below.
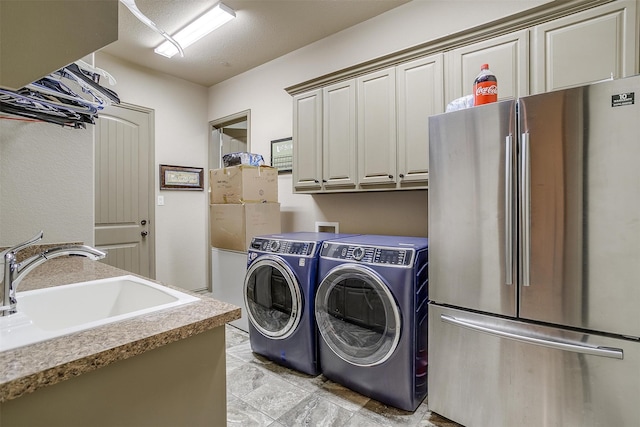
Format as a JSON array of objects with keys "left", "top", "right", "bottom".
[{"left": 446, "top": 30, "right": 529, "bottom": 102}]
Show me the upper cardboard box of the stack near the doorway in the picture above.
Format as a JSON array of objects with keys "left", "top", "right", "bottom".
[{"left": 209, "top": 165, "right": 278, "bottom": 205}]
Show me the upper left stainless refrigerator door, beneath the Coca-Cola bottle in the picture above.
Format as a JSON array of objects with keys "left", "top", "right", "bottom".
[{"left": 429, "top": 101, "right": 516, "bottom": 316}]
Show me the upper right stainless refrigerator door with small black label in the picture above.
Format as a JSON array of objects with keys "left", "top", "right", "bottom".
[{"left": 518, "top": 76, "right": 640, "bottom": 337}]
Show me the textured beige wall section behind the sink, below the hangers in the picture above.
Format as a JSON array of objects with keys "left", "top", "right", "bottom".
[{"left": 0, "top": 119, "right": 94, "bottom": 247}]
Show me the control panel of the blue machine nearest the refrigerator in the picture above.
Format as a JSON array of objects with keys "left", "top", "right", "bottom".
[{"left": 320, "top": 242, "right": 415, "bottom": 267}]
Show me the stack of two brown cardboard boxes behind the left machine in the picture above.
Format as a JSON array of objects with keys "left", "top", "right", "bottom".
[{"left": 209, "top": 165, "right": 281, "bottom": 252}]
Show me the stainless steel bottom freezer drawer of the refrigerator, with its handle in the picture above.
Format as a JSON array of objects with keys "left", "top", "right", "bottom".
[{"left": 428, "top": 304, "right": 640, "bottom": 427}]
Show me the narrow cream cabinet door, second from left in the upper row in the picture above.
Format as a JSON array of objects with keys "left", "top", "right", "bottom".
[{"left": 322, "top": 79, "right": 357, "bottom": 189}]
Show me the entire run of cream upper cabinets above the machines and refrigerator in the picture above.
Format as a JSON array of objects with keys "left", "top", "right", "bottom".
[{"left": 287, "top": 0, "right": 640, "bottom": 193}]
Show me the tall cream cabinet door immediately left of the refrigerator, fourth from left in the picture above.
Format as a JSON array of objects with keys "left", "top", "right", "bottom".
[{"left": 396, "top": 54, "right": 444, "bottom": 184}]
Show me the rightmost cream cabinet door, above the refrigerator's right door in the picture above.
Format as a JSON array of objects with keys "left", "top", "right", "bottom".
[{"left": 531, "top": 1, "right": 637, "bottom": 93}]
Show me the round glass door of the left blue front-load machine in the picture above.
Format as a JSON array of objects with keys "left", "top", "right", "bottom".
[{"left": 244, "top": 256, "right": 303, "bottom": 339}]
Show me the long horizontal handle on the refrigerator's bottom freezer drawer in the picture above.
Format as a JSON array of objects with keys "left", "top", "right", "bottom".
[{"left": 440, "top": 314, "right": 624, "bottom": 360}]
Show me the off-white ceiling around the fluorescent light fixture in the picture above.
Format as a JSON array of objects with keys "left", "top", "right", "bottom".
[{"left": 102, "top": 0, "right": 410, "bottom": 86}]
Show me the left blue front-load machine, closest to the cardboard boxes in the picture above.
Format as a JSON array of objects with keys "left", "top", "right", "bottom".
[{"left": 244, "top": 232, "right": 353, "bottom": 375}]
